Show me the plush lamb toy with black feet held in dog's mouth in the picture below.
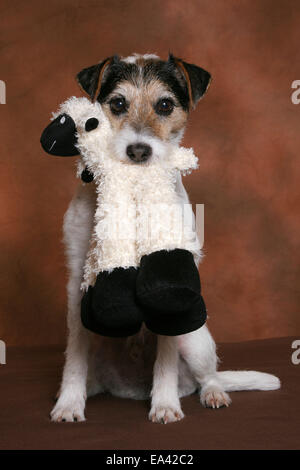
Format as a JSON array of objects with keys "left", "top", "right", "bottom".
[{"left": 41, "top": 97, "right": 206, "bottom": 337}]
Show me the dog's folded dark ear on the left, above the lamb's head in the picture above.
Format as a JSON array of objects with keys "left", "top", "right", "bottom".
[{"left": 76, "top": 56, "right": 117, "bottom": 101}]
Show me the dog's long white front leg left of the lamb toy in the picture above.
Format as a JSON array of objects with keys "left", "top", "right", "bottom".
[{"left": 51, "top": 185, "right": 95, "bottom": 421}]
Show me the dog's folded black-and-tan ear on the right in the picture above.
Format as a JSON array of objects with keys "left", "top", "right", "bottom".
[{"left": 168, "top": 54, "right": 211, "bottom": 108}]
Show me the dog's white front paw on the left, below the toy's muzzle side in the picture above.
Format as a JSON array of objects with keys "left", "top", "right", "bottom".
[{"left": 50, "top": 396, "right": 85, "bottom": 423}]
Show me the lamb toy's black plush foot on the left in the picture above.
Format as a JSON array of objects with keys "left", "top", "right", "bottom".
[{"left": 81, "top": 267, "right": 143, "bottom": 338}]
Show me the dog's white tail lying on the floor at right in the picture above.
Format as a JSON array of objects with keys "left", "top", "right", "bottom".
[{"left": 217, "top": 370, "right": 281, "bottom": 392}]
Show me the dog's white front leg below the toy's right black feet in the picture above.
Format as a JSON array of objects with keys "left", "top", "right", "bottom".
[{"left": 149, "top": 336, "right": 184, "bottom": 424}]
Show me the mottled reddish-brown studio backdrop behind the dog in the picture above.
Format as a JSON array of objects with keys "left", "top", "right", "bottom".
[{"left": 0, "top": 0, "right": 300, "bottom": 345}]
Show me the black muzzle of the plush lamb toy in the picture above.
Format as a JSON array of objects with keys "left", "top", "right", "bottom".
[{"left": 41, "top": 114, "right": 79, "bottom": 157}]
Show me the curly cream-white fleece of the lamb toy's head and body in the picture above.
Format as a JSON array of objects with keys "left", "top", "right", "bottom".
[{"left": 54, "top": 97, "right": 199, "bottom": 290}]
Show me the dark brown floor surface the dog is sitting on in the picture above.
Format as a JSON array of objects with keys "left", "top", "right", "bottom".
[{"left": 0, "top": 338, "right": 300, "bottom": 450}]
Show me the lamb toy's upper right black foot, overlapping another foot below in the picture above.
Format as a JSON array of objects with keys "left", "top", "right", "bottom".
[{"left": 137, "top": 249, "right": 201, "bottom": 312}]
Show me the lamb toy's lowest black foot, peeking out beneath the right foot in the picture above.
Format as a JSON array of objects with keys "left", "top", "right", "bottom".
[{"left": 144, "top": 295, "right": 207, "bottom": 336}]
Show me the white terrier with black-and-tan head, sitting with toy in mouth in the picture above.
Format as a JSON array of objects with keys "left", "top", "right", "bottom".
[{"left": 51, "top": 54, "right": 280, "bottom": 424}]
